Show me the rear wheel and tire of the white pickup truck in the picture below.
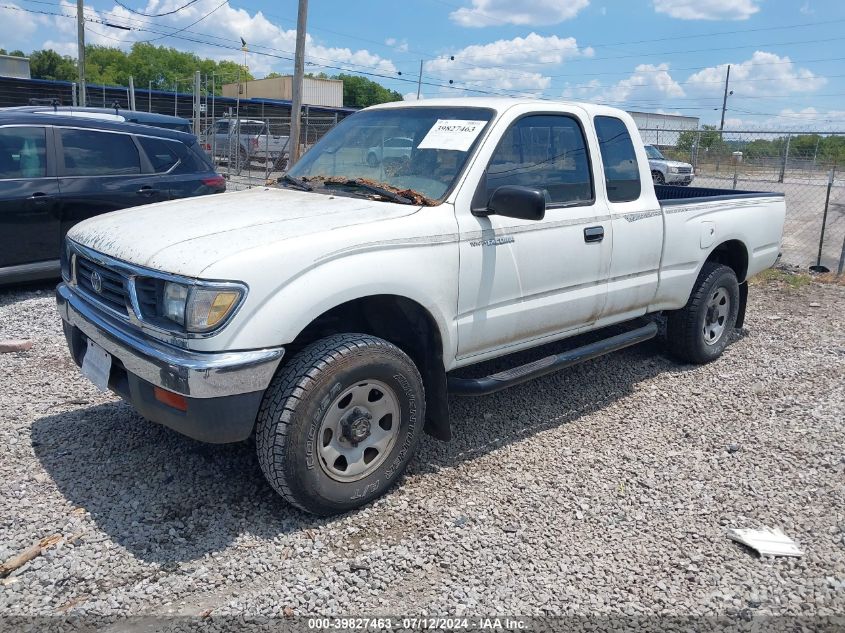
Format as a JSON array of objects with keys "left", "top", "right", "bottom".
[{"left": 666, "top": 262, "right": 739, "bottom": 364}]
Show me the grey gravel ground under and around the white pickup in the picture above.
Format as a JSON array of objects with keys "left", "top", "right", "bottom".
[{"left": 0, "top": 272, "right": 845, "bottom": 628}]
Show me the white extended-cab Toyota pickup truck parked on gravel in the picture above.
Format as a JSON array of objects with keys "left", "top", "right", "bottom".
[{"left": 57, "top": 99, "right": 785, "bottom": 515}]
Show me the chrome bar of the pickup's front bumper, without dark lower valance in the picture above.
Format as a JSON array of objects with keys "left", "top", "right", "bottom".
[{"left": 56, "top": 283, "right": 285, "bottom": 398}]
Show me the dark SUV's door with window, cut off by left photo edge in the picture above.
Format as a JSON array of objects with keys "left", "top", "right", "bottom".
[{"left": 0, "top": 124, "right": 61, "bottom": 268}]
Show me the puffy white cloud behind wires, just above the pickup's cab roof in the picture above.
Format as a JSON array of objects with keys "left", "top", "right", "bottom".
[{"left": 424, "top": 33, "right": 594, "bottom": 94}]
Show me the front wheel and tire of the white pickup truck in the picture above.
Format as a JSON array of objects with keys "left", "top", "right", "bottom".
[{"left": 256, "top": 334, "right": 425, "bottom": 516}]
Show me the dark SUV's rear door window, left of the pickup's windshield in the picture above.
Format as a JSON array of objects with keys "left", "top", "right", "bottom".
[{"left": 58, "top": 128, "right": 141, "bottom": 176}]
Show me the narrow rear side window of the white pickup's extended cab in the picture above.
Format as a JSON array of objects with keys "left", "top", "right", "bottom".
[{"left": 595, "top": 116, "right": 642, "bottom": 202}]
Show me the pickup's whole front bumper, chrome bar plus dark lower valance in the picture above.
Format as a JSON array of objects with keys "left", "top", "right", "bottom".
[{"left": 56, "top": 283, "right": 284, "bottom": 443}]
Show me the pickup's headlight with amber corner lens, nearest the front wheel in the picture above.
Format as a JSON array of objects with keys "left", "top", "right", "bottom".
[{"left": 161, "top": 281, "right": 243, "bottom": 332}]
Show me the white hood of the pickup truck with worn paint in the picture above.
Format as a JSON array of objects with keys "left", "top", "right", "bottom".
[{"left": 68, "top": 187, "right": 420, "bottom": 277}]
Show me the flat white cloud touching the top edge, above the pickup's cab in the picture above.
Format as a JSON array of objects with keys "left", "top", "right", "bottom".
[{"left": 449, "top": 0, "right": 590, "bottom": 27}]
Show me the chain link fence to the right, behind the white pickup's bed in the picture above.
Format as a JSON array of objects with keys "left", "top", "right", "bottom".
[{"left": 640, "top": 128, "right": 845, "bottom": 271}]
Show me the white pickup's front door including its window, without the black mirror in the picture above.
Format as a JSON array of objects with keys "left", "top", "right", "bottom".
[{"left": 457, "top": 114, "right": 612, "bottom": 359}]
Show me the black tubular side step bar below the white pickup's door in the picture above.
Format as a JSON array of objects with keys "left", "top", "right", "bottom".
[{"left": 448, "top": 321, "right": 657, "bottom": 396}]
